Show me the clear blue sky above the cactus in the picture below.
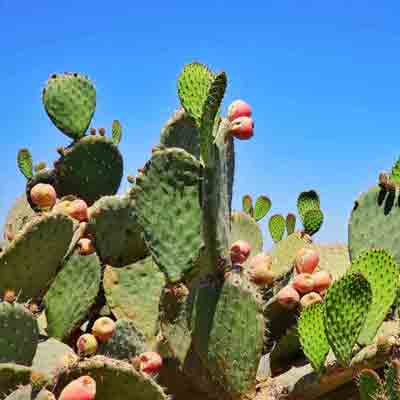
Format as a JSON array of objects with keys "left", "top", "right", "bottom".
[{"left": 0, "top": 0, "right": 400, "bottom": 248}]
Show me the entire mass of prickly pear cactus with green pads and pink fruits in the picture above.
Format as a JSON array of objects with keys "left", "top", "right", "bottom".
[{"left": 0, "top": 63, "right": 400, "bottom": 400}]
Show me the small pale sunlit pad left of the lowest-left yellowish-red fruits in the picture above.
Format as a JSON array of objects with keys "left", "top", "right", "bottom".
[{"left": 32, "top": 338, "right": 77, "bottom": 380}]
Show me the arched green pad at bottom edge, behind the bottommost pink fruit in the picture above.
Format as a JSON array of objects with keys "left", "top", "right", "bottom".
[{"left": 55, "top": 356, "right": 168, "bottom": 400}]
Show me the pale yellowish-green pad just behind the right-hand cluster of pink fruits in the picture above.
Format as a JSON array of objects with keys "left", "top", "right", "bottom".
[{"left": 268, "top": 232, "right": 309, "bottom": 279}]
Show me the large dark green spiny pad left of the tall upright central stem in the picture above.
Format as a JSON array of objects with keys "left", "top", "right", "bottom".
[{"left": 132, "top": 148, "right": 203, "bottom": 282}]
